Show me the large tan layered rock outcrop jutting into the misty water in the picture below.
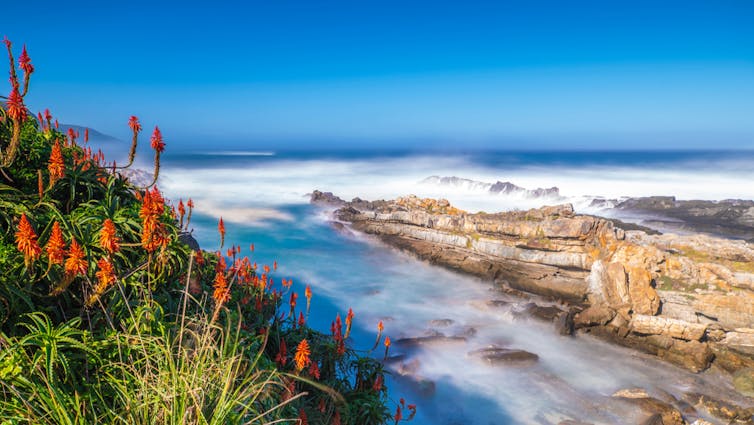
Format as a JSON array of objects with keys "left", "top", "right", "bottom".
[{"left": 313, "top": 192, "right": 754, "bottom": 378}]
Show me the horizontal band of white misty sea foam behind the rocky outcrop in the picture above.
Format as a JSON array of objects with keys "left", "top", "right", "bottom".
[{"left": 161, "top": 152, "right": 754, "bottom": 219}]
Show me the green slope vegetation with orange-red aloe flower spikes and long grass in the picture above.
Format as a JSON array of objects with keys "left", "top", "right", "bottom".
[{"left": 0, "top": 39, "right": 406, "bottom": 424}]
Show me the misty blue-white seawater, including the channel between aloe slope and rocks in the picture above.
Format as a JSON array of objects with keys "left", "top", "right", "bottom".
[{"left": 161, "top": 153, "right": 754, "bottom": 424}]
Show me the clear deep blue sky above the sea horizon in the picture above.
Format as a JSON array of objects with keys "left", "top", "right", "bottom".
[{"left": 0, "top": 0, "right": 754, "bottom": 149}]
